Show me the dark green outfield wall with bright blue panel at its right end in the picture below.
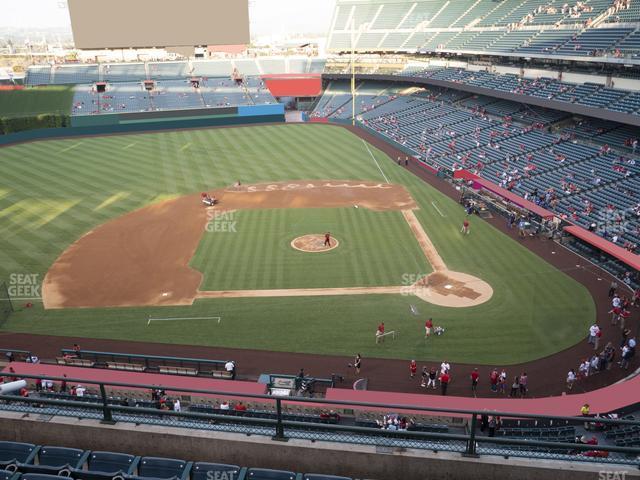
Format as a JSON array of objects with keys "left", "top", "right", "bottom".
[{"left": 0, "top": 103, "right": 284, "bottom": 146}]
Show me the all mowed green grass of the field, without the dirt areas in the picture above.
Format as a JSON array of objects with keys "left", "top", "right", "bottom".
[{"left": 0, "top": 125, "right": 595, "bottom": 364}]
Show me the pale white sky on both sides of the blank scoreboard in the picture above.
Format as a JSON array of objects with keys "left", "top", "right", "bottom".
[{"left": 0, "top": 0, "right": 335, "bottom": 36}]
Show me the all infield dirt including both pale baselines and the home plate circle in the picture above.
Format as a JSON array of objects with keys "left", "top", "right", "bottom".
[{"left": 43, "top": 180, "right": 493, "bottom": 308}]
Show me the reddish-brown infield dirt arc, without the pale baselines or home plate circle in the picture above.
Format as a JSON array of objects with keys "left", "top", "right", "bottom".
[{"left": 42, "top": 180, "right": 417, "bottom": 309}]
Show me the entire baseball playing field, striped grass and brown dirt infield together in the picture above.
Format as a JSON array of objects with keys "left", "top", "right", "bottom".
[{"left": 0, "top": 125, "right": 595, "bottom": 365}]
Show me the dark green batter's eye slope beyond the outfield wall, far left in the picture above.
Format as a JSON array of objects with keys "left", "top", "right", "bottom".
[{"left": 0, "top": 85, "right": 73, "bottom": 117}]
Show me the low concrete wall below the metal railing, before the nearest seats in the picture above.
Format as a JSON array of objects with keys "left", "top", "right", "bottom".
[{"left": 0, "top": 412, "right": 640, "bottom": 480}]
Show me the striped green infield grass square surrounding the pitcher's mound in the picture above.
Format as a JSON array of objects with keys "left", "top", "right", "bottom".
[{"left": 191, "top": 207, "right": 431, "bottom": 290}]
